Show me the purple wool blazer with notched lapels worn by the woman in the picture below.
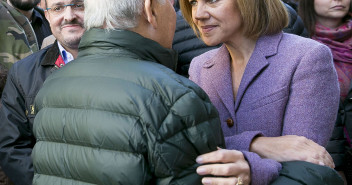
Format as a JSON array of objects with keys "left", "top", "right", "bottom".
[{"left": 189, "top": 33, "right": 339, "bottom": 185}]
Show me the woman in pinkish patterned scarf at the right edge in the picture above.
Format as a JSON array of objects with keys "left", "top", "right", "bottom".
[{"left": 298, "top": 0, "right": 352, "bottom": 184}]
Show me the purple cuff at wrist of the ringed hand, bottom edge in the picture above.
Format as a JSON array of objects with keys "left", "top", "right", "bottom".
[{"left": 241, "top": 151, "right": 281, "bottom": 185}]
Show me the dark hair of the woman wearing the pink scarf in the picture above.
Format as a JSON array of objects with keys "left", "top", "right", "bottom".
[{"left": 298, "top": 0, "right": 352, "bottom": 37}]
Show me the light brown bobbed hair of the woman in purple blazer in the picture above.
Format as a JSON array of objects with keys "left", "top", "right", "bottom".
[{"left": 180, "top": 0, "right": 289, "bottom": 39}]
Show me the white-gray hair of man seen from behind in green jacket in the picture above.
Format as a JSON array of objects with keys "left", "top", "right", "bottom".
[{"left": 84, "top": 0, "right": 164, "bottom": 30}]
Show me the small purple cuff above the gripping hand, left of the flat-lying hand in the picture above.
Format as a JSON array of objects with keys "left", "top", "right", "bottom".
[{"left": 225, "top": 131, "right": 263, "bottom": 151}]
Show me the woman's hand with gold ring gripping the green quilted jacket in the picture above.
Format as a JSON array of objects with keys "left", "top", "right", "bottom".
[{"left": 197, "top": 148, "right": 251, "bottom": 185}]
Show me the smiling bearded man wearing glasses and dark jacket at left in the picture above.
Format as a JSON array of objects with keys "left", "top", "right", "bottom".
[{"left": 0, "top": 0, "right": 84, "bottom": 185}]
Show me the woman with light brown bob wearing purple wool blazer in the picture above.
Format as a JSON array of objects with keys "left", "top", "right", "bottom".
[{"left": 180, "top": 0, "right": 339, "bottom": 184}]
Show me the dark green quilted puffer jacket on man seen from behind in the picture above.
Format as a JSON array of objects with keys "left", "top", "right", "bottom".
[{"left": 32, "top": 29, "right": 224, "bottom": 185}]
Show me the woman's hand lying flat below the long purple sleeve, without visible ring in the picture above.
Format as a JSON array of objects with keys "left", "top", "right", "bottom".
[{"left": 250, "top": 135, "right": 335, "bottom": 168}]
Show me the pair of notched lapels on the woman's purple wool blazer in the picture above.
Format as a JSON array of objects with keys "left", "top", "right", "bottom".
[{"left": 203, "top": 33, "right": 282, "bottom": 114}]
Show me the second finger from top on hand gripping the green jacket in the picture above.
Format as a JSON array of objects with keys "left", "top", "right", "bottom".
[{"left": 197, "top": 163, "right": 245, "bottom": 177}]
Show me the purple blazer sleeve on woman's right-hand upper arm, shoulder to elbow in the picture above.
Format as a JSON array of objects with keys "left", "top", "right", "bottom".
[{"left": 282, "top": 45, "right": 340, "bottom": 146}]
